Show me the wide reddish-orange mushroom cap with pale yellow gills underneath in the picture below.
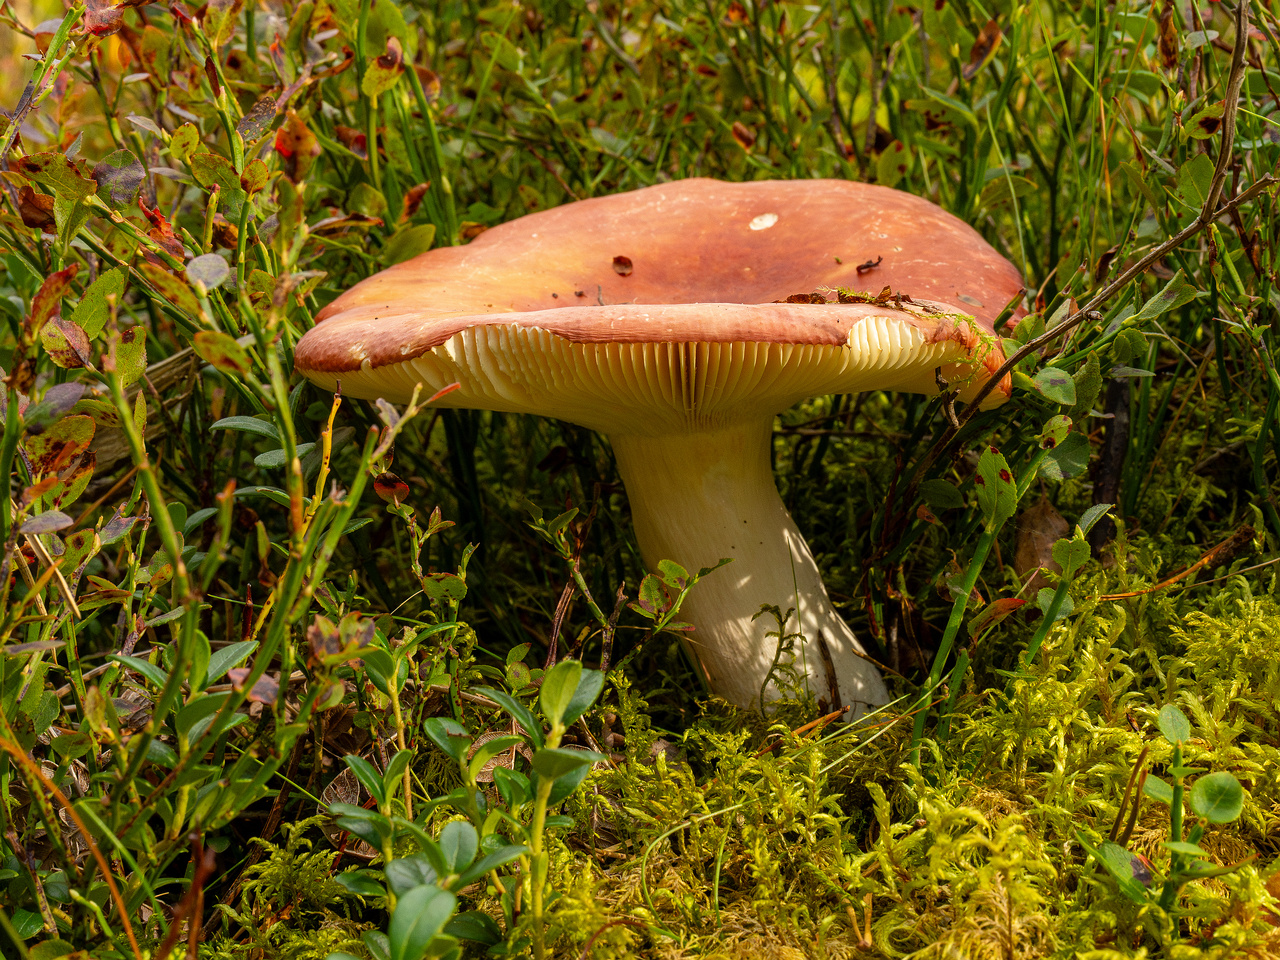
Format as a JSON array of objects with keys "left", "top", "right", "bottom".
[{"left": 294, "top": 179, "right": 1023, "bottom": 433}]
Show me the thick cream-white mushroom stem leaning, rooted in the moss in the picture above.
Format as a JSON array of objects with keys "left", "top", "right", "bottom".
[{"left": 609, "top": 416, "right": 888, "bottom": 716}]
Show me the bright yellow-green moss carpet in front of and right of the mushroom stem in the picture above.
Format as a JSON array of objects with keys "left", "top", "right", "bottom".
[{"left": 532, "top": 570, "right": 1280, "bottom": 960}]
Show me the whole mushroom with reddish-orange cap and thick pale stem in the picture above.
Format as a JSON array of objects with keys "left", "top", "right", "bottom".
[{"left": 294, "top": 179, "right": 1023, "bottom": 716}]
